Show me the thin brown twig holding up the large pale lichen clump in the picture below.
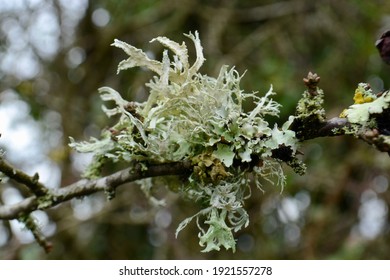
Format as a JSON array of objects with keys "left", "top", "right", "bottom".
[{"left": 0, "top": 73, "right": 390, "bottom": 254}]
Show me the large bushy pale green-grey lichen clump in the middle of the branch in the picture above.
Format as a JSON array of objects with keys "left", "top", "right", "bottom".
[{"left": 70, "top": 32, "right": 302, "bottom": 252}]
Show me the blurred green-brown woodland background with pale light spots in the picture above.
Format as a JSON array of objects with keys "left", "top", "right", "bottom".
[{"left": 0, "top": 0, "right": 390, "bottom": 259}]
